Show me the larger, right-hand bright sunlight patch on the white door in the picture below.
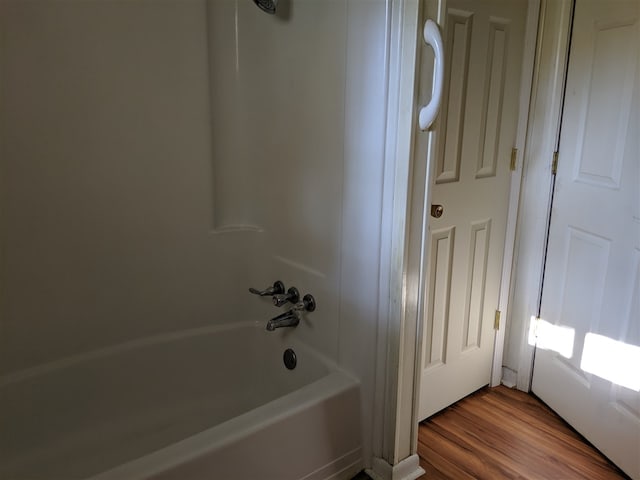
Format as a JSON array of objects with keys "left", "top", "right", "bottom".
[{"left": 580, "top": 333, "right": 640, "bottom": 392}]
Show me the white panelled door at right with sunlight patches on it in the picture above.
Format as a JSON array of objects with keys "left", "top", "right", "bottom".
[{"left": 533, "top": 0, "right": 640, "bottom": 479}]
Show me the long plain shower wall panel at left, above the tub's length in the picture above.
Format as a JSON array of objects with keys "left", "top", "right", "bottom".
[{"left": 0, "top": 0, "right": 253, "bottom": 373}]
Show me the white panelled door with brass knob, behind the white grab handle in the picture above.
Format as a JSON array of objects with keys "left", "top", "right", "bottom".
[{"left": 419, "top": 0, "right": 527, "bottom": 419}]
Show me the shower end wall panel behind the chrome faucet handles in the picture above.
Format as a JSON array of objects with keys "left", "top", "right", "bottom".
[{"left": 208, "top": 0, "right": 349, "bottom": 364}]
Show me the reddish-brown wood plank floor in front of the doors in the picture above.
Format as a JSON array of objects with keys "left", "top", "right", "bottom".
[{"left": 418, "top": 386, "right": 628, "bottom": 480}]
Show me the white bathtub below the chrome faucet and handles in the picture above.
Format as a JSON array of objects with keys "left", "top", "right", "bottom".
[{"left": 0, "top": 323, "right": 362, "bottom": 480}]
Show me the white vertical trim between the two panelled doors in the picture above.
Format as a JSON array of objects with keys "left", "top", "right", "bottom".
[{"left": 503, "top": 0, "right": 574, "bottom": 392}]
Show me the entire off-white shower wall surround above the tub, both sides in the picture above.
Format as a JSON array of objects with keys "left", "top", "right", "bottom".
[{"left": 0, "top": 0, "right": 393, "bottom": 463}]
